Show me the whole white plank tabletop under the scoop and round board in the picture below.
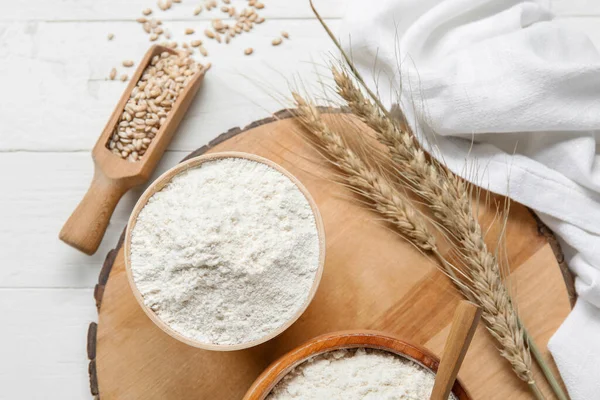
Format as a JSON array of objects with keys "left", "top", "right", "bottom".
[{"left": 0, "top": 0, "right": 600, "bottom": 400}]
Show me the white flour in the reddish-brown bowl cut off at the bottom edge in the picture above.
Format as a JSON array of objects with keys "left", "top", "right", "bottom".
[{"left": 267, "top": 348, "right": 456, "bottom": 400}]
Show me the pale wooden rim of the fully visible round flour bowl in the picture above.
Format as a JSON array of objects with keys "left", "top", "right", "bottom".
[{"left": 124, "top": 152, "right": 325, "bottom": 351}]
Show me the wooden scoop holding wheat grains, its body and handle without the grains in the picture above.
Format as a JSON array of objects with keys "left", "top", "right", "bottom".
[{"left": 59, "top": 45, "right": 205, "bottom": 255}]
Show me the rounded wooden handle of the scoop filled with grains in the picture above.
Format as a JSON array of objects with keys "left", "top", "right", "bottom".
[{"left": 58, "top": 168, "right": 129, "bottom": 255}]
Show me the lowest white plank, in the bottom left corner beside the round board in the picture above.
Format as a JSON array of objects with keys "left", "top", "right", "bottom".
[{"left": 0, "top": 290, "right": 97, "bottom": 400}]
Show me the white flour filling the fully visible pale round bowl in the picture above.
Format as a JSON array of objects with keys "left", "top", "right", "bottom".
[{"left": 131, "top": 158, "right": 319, "bottom": 345}]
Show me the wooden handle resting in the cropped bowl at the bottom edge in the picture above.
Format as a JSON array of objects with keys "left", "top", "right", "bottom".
[{"left": 430, "top": 300, "right": 481, "bottom": 400}]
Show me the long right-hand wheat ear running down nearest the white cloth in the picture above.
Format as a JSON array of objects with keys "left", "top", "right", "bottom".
[{"left": 333, "top": 68, "right": 539, "bottom": 391}]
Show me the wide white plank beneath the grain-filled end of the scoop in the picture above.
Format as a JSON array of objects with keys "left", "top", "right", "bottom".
[{"left": 0, "top": 20, "right": 338, "bottom": 151}]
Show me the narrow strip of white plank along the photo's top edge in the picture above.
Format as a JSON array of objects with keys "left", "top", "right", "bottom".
[{"left": 0, "top": 0, "right": 347, "bottom": 21}]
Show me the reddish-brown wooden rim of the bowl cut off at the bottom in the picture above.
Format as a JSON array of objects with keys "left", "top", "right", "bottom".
[{"left": 243, "top": 330, "right": 471, "bottom": 400}]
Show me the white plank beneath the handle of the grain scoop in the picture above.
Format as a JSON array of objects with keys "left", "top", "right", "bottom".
[{"left": 0, "top": 152, "right": 190, "bottom": 288}]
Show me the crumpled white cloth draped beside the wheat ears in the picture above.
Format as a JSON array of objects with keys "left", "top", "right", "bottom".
[{"left": 339, "top": 0, "right": 600, "bottom": 400}]
